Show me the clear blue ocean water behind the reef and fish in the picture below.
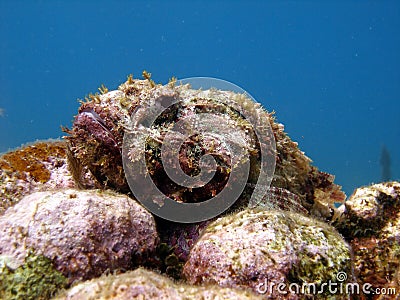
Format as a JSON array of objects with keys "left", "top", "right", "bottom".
[{"left": 0, "top": 0, "right": 400, "bottom": 194}]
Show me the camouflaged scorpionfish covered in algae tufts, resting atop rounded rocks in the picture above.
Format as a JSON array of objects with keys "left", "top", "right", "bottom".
[{"left": 64, "top": 72, "right": 345, "bottom": 220}]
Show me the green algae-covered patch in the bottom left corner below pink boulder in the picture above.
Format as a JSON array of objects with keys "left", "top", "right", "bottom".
[{"left": 0, "top": 252, "right": 67, "bottom": 300}]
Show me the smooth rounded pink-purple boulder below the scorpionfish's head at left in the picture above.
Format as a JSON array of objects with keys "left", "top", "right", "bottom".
[{"left": 0, "top": 189, "right": 158, "bottom": 283}]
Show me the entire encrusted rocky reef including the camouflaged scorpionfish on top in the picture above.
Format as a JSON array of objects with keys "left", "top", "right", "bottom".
[{"left": 0, "top": 72, "right": 400, "bottom": 299}]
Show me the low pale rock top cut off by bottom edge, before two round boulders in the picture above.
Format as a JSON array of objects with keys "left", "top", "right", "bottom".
[{"left": 54, "top": 269, "right": 262, "bottom": 300}]
